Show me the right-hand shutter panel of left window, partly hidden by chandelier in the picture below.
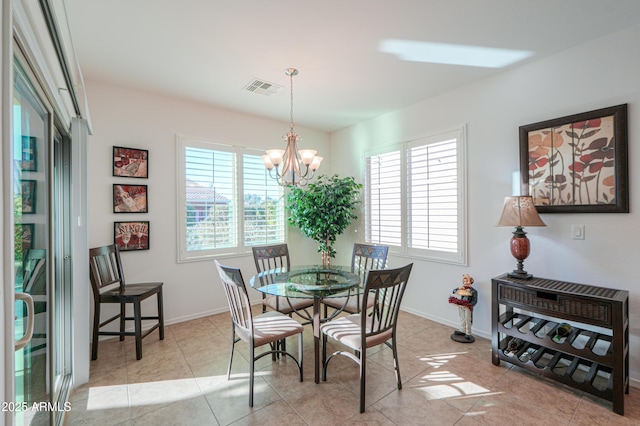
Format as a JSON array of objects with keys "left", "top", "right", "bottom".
[{"left": 242, "top": 154, "right": 285, "bottom": 246}]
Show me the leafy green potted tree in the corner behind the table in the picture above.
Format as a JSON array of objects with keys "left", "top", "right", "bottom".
[{"left": 286, "top": 175, "right": 362, "bottom": 266}]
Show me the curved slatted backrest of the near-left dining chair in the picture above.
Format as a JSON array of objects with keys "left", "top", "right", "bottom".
[{"left": 214, "top": 260, "right": 253, "bottom": 339}]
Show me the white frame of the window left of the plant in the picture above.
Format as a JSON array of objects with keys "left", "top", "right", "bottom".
[{"left": 176, "top": 135, "right": 287, "bottom": 263}]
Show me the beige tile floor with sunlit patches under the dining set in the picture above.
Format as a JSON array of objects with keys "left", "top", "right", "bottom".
[{"left": 65, "top": 313, "right": 640, "bottom": 426}]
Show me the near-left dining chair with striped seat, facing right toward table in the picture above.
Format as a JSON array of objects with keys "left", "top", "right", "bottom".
[{"left": 215, "top": 260, "right": 304, "bottom": 407}]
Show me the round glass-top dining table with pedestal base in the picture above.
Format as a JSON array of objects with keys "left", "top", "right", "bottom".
[{"left": 249, "top": 265, "right": 364, "bottom": 383}]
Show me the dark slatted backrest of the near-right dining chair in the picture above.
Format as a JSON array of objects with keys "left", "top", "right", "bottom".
[{"left": 361, "top": 263, "right": 413, "bottom": 339}]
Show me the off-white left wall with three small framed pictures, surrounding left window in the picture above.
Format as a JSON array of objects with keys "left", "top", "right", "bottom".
[{"left": 87, "top": 81, "right": 329, "bottom": 324}]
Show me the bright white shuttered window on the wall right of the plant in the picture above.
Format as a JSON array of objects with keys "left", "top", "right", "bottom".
[{"left": 365, "top": 127, "right": 466, "bottom": 265}]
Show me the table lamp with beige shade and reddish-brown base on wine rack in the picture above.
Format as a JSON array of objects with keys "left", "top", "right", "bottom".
[{"left": 498, "top": 196, "right": 547, "bottom": 280}]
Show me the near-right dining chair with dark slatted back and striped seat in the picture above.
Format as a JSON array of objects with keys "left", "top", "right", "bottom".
[{"left": 320, "top": 263, "right": 413, "bottom": 413}]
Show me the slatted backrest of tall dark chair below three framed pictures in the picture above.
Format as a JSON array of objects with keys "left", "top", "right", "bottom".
[{"left": 89, "top": 244, "right": 125, "bottom": 297}]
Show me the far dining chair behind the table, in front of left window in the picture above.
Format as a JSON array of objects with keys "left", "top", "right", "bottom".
[{"left": 252, "top": 243, "right": 313, "bottom": 320}]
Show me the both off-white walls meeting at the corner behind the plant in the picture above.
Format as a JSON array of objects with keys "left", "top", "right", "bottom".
[{"left": 87, "top": 23, "right": 640, "bottom": 378}]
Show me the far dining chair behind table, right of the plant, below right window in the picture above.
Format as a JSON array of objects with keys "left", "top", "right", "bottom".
[{"left": 322, "top": 243, "right": 389, "bottom": 318}]
